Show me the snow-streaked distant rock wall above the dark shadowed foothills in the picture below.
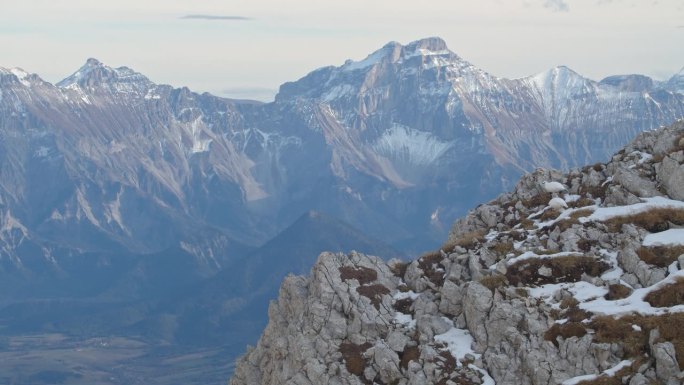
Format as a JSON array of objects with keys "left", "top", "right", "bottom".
[{"left": 0, "top": 38, "right": 684, "bottom": 278}]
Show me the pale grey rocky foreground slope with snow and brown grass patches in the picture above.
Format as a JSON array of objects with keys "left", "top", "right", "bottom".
[{"left": 230, "top": 121, "right": 684, "bottom": 385}]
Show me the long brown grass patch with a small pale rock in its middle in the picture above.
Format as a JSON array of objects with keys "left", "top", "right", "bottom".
[{"left": 506, "top": 256, "right": 609, "bottom": 286}]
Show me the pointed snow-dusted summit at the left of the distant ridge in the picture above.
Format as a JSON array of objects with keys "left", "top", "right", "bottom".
[{"left": 56, "top": 58, "right": 151, "bottom": 90}]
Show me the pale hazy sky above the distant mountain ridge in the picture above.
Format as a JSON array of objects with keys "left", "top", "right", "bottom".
[{"left": 0, "top": 0, "right": 684, "bottom": 99}]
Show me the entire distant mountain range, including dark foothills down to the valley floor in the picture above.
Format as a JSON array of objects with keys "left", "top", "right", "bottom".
[{"left": 0, "top": 38, "right": 684, "bottom": 380}]
